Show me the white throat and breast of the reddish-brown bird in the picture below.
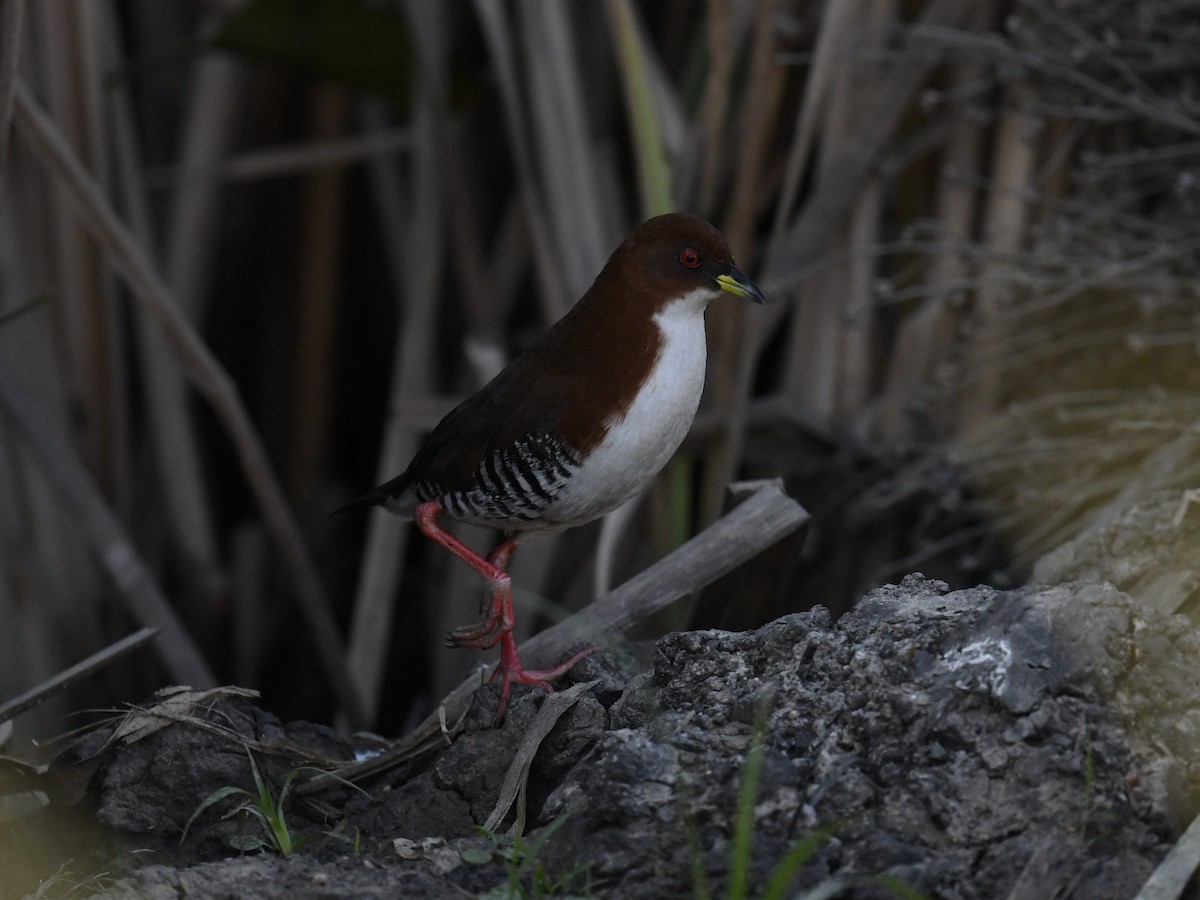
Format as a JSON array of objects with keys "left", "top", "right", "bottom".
[{"left": 539, "top": 290, "right": 715, "bottom": 528}]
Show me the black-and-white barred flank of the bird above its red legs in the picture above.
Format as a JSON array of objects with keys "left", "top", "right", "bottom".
[{"left": 413, "top": 434, "right": 580, "bottom": 522}]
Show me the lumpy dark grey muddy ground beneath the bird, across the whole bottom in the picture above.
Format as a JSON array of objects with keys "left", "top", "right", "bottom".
[{"left": 0, "top": 576, "right": 1200, "bottom": 900}]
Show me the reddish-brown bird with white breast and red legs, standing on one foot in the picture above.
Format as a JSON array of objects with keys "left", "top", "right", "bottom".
[{"left": 342, "top": 212, "right": 766, "bottom": 724}]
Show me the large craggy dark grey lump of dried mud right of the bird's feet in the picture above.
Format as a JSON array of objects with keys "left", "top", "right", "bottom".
[{"left": 545, "top": 578, "right": 1176, "bottom": 898}]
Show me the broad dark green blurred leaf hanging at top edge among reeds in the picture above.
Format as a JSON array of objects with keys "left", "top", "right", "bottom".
[{"left": 214, "top": 0, "right": 412, "bottom": 106}]
